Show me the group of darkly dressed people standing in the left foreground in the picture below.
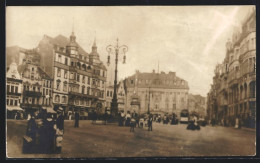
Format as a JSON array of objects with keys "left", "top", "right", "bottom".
[{"left": 23, "top": 107, "right": 64, "bottom": 154}]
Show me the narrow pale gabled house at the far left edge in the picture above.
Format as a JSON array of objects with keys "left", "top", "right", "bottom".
[{"left": 6, "top": 62, "right": 22, "bottom": 118}]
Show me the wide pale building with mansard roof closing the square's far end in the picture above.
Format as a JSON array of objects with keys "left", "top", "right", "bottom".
[{"left": 125, "top": 70, "right": 189, "bottom": 116}]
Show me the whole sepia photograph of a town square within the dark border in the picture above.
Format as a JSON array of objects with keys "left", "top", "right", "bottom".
[{"left": 5, "top": 5, "right": 256, "bottom": 159}]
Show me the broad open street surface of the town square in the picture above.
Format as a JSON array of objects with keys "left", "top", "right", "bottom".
[{"left": 7, "top": 120, "right": 256, "bottom": 158}]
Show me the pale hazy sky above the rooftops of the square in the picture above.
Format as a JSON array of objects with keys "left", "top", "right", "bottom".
[{"left": 6, "top": 6, "right": 253, "bottom": 96}]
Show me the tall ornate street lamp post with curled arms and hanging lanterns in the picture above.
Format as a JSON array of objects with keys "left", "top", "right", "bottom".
[{"left": 106, "top": 38, "right": 128, "bottom": 116}]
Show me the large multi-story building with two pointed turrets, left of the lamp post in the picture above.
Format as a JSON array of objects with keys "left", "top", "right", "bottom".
[{"left": 38, "top": 32, "right": 107, "bottom": 114}]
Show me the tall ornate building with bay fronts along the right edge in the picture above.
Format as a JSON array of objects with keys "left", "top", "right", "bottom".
[{"left": 208, "top": 8, "right": 256, "bottom": 127}]
